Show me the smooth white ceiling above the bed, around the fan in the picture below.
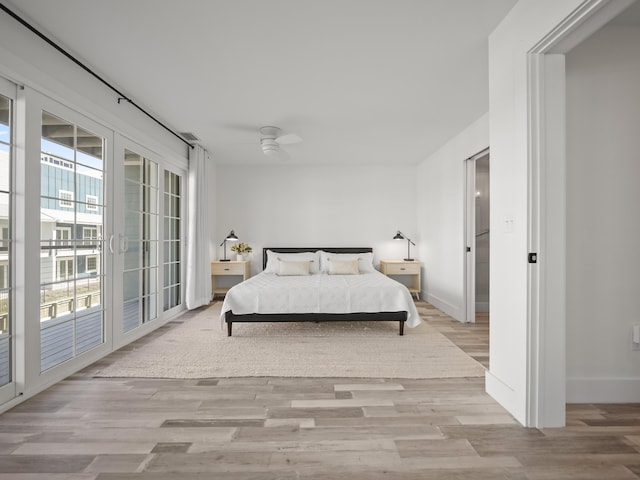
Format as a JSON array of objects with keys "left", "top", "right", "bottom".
[{"left": 5, "top": 0, "right": 516, "bottom": 164}]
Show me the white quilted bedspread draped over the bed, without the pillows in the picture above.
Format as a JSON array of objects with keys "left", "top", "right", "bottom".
[{"left": 221, "top": 271, "right": 422, "bottom": 327}]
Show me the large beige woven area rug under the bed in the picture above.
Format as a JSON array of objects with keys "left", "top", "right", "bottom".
[{"left": 94, "top": 302, "right": 485, "bottom": 379}]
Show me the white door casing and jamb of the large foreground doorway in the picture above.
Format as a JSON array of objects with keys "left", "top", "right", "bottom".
[{"left": 525, "top": 0, "right": 632, "bottom": 428}]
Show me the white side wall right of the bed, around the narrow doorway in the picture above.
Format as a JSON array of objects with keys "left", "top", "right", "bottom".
[{"left": 416, "top": 114, "right": 489, "bottom": 321}]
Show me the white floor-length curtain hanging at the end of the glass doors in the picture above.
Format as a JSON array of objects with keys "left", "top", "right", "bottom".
[{"left": 186, "top": 145, "right": 211, "bottom": 310}]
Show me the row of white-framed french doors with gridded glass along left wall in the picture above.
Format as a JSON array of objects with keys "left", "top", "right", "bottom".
[{"left": 0, "top": 82, "right": 184, "bottom": 408}]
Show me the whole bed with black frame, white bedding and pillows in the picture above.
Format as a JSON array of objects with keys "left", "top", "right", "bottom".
[{"left": 221, "top": 247, "right": 421, "bottom": 336}]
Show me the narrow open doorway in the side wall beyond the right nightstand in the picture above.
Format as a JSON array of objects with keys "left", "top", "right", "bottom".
[{"left": 464, "top": 149, "right": 490, "bottom": 323}]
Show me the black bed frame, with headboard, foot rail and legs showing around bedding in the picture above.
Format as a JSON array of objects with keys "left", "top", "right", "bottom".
[{"left": 224, "top": 247, "right": 407, "bottom": 337}]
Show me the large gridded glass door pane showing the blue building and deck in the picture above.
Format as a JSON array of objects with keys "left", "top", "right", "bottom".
[{"left": 40, "top": 111, "right": 106, "bottom": 371}]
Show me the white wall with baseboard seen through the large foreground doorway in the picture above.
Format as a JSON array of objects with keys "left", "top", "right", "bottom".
[{"left": 566, "top": 27, "right": 640, "bottom": 402}]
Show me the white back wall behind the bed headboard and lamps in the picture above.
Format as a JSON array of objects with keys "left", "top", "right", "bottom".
[{"left": 216, "top": 163, "right": 420, "bottom": 273}]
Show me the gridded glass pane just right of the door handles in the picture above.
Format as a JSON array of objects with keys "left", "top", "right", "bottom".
[{"left": 119, "top": 149, "right": 159, "bottom": 332}]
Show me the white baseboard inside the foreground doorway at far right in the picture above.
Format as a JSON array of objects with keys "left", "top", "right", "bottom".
[{"left": 567, "top": 377, "right": 640, "bottom": 403}]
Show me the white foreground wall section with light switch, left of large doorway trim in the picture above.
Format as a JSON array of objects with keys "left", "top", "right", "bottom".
[{"left": 486, "top": 0, "right": 583, "bottom": 425}]
